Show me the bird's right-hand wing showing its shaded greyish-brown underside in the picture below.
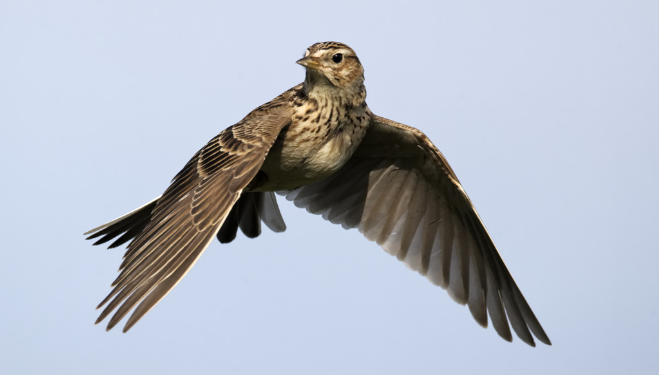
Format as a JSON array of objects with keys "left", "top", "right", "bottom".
[{"left": 286, "top": 116, "right": 551, "bottom": 346}]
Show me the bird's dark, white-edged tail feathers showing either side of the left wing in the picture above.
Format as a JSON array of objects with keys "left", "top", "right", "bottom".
[{"left": 85, "top": 192, "right": 286, "bottom": 249}]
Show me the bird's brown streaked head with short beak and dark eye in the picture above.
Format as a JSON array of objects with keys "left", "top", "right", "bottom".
[{"left": 297, "top": 42, "right": 364, "bottom": 89}]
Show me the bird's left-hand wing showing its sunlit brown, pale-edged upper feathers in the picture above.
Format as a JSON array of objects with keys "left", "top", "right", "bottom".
[{"left": 87, "top": 101, "right": 291, "bottom": 332}]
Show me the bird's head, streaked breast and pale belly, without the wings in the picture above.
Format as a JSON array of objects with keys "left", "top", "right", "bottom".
[{"left": 255, "top": 43, "right": 372, "bottom": 191}]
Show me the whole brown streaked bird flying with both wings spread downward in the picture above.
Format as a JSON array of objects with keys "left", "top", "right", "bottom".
[{"left": 85, "top": 42, "right": 551, "bottom": 346}]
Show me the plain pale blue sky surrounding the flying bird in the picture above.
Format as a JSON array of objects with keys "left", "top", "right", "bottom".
[{"left": 0, "top": 0, "right": 659, "bottom": 374}]
